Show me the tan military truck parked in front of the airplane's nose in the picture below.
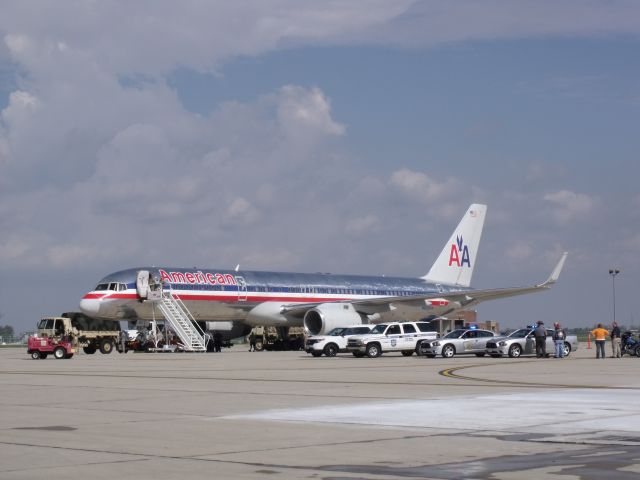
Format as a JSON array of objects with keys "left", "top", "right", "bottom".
[{"left": 38, "top": 312, "right": 120, "bottom": 354}]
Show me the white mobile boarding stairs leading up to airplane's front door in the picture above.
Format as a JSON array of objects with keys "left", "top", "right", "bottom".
[{"left": 156, "top": 289, "right": 209, "bottom": 352}]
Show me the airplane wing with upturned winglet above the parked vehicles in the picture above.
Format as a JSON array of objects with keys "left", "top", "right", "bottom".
[{"left": 280, "top": 252, "right": 567, "bottom": 317}]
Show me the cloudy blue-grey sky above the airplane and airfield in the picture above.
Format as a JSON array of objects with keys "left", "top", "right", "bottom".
[{"left": 0, "top": 0, "right": 640, "bottom": 332}]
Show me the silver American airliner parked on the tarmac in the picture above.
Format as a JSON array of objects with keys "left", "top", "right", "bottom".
[{"left": 80, "top": 204, "right": 567, "bottom": 339}]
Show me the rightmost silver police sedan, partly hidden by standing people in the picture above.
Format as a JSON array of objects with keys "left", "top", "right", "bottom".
[{"left": 485, "top": 325, "right": 578, "bottom": 358}]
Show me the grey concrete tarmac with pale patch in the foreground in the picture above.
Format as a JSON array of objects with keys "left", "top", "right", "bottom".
[{"left": 0, "top": 344, "right": 640, "bottom": 480}]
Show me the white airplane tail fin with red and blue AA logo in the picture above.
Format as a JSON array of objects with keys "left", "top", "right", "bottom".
[{"left": 422, "top": 203, "right": 487, "bottom": 287}]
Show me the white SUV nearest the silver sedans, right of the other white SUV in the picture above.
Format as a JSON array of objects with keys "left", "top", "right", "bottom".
[{"left": 347, "top": 322, "right": 438, "bottom": 358}]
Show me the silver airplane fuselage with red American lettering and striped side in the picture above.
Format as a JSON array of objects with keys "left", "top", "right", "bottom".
[{"left": 80, "top": 267, "right": 461, "bottom": 326}]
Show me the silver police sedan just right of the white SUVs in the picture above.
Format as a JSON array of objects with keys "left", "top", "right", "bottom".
[{"left": 416, "top": 328, "right": 495, "bottom": 358}]
